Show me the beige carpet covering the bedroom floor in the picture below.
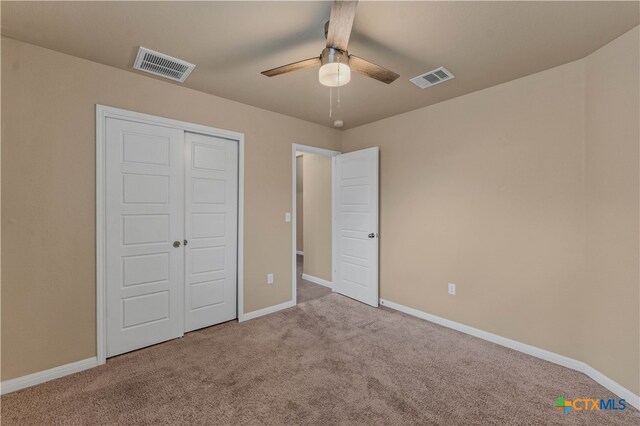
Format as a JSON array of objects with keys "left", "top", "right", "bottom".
[{"left": 2, "top": 294, "right": 640, "bottom": 425}]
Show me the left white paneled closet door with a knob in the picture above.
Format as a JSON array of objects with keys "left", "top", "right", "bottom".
[{"left": 105, "top": 118, "right": 184, "bottom": 356}]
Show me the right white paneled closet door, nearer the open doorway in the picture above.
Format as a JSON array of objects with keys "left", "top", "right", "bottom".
[{"left": 185, "top": 133, "right": 238, "bottom": 331}]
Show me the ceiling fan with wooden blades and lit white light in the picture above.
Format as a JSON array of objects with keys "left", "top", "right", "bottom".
[{"left": 261, "top": 0, "right": 400, "bottom": 87}]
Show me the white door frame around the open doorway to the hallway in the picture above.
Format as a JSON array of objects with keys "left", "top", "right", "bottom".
[{"left": 291, "top": 143, "right": 341, "bottom": 306}]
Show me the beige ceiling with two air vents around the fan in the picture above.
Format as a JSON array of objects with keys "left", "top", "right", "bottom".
[{"left": 1, "top": 1, "right": 640, "bottom": 129}]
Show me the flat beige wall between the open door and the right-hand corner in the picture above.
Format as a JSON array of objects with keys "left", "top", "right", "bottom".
[{"left": 343, "top": 57, "right": 584, "bottom": 357}]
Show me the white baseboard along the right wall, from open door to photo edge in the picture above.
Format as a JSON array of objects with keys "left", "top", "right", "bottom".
[{"left": 380, "top": 299, "right": 640, "bottom": 410}]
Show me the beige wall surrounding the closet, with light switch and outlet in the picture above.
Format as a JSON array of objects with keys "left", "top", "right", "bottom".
[{"left": 1, "top": 39, "right": 340, "bottom": 380}]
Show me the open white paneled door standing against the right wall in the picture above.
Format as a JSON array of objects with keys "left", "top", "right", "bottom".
[{"left": 334, "top": 147, "right": 379, "bottom": 306}]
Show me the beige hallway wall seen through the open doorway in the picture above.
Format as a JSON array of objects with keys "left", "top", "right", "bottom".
[{"left": 302, "top": 152, "right": 332, "bottom": 281}]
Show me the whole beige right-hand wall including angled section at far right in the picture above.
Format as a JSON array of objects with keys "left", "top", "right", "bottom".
[{"left": 342, "top": 28, "right": 640, "bottom": 393}]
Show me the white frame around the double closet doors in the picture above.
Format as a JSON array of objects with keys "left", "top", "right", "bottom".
[{"left": 96, "top": 104, "right": 244, "bottom": 365}]
